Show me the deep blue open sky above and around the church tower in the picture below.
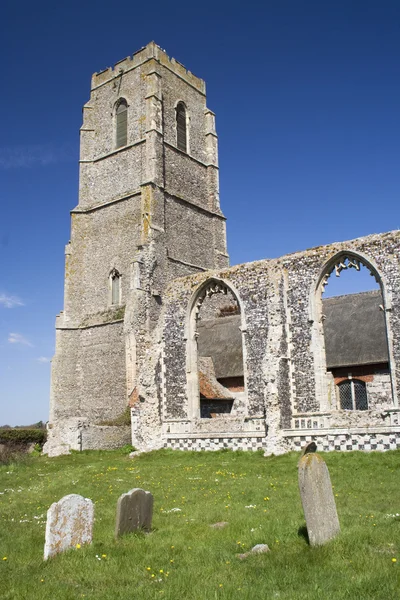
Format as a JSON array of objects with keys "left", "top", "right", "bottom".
[{"left": 0, "top": 0, "right": 400, "bottom": 425}]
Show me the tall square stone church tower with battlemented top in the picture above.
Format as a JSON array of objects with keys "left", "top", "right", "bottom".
[{"left": 46, "top": 42, "right": 229, "bottom": 454}]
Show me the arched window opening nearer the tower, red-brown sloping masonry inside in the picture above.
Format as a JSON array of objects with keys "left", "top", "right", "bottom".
[{"left": 191, "top": 280, "right": 245, "bottom": 419}]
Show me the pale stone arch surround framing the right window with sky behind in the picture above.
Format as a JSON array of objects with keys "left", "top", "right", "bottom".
[{"left": 309, "top": 250, "right": 398, "bottom": 412}]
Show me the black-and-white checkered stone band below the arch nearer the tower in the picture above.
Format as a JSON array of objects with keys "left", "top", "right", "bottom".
[{"left": 164, "top": 437, "right": 266, "bottom": 450}]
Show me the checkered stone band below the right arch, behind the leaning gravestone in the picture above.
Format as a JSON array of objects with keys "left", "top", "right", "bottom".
[{"left": 286, "top": 431, "right": 400, "bottom": 452}]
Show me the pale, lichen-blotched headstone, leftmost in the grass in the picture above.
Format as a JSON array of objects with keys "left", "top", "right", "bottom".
[{"left": 44, "top": 494, "right": 94, "bottom": 560}]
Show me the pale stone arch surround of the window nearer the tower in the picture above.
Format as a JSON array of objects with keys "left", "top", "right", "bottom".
[{"left": 185, "top": 277, "right": 247, "bottom": 419}]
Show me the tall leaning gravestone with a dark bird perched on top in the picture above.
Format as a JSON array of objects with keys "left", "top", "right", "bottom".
[{"left": 298, "top": 453, "right": 340, "bottom": 546}]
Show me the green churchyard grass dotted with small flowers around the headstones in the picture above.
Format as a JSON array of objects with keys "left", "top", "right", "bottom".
[{"left": 0, "top": 451, "right": 400, "bottom": 600}]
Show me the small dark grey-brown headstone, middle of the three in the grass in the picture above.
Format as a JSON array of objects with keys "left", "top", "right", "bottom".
[{"left": 115, "top": 488, "right": 153, "bottom": 537}]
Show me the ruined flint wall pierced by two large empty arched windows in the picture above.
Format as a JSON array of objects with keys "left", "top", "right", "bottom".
[{"left": 157, "top": 231, "right": 400, "bottom": 451}]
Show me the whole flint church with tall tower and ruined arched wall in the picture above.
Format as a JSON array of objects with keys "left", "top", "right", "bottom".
[{"left": 45, "top": 42, "right": 400, "bottom": 456}]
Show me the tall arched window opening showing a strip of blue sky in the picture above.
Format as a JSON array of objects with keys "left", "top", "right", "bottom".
[{"left": 315, "top": 253, "right": 393, "bottom": 410}]
